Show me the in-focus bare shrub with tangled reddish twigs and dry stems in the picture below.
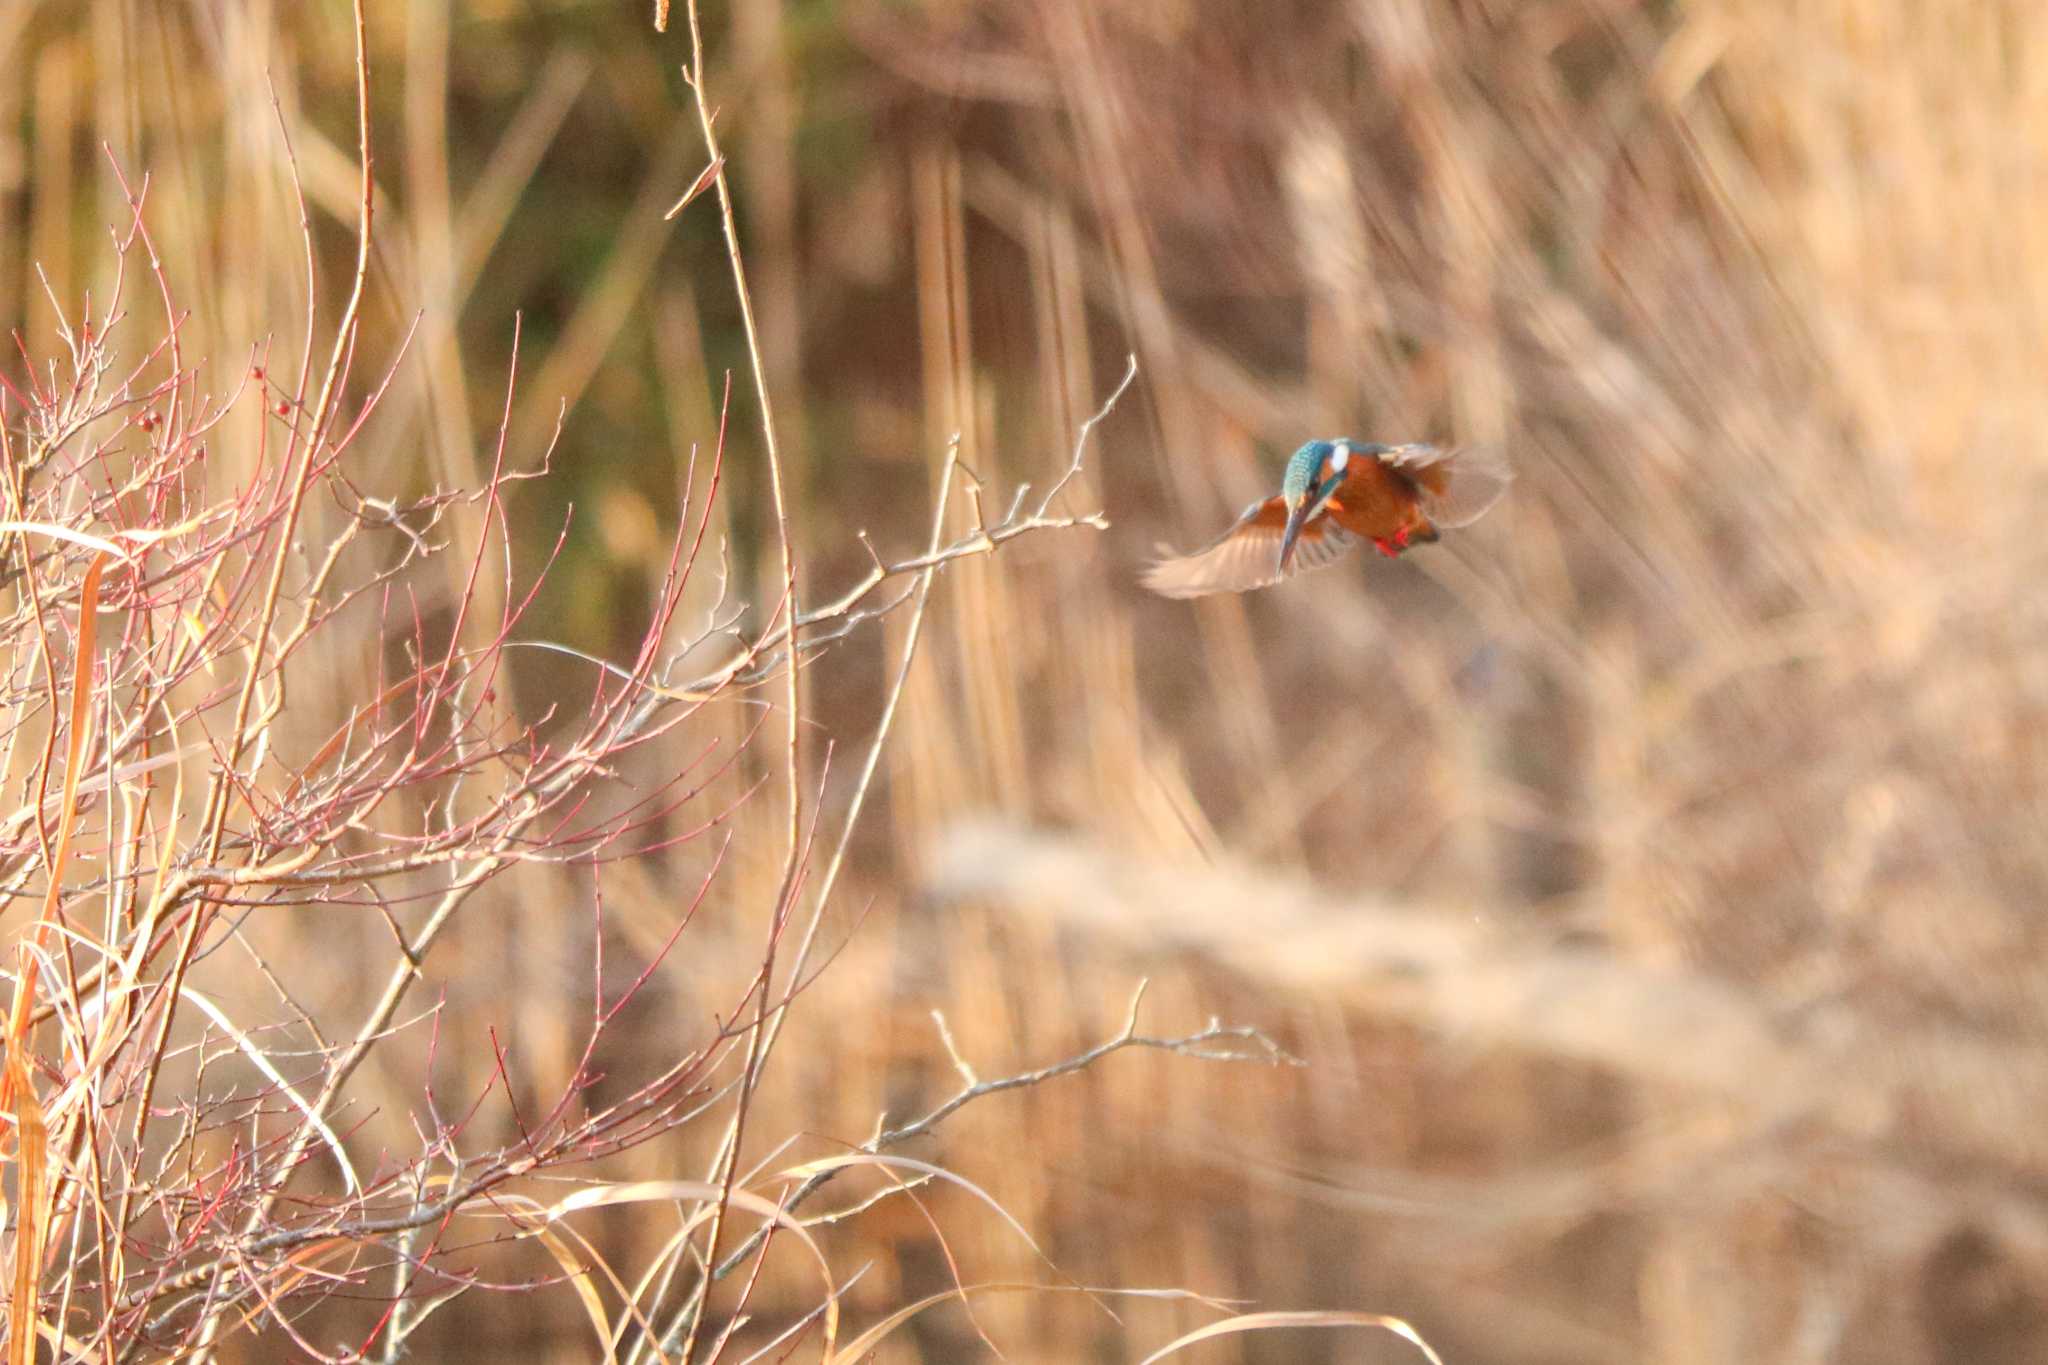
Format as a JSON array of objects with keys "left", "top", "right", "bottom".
[{"left": 0, "top": 6, "right": 1343, "bottom": 1361}]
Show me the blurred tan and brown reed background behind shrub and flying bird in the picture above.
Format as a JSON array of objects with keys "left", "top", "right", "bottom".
[{"left": 0, "top": 0, "right": 2048, "bottom": 1365}]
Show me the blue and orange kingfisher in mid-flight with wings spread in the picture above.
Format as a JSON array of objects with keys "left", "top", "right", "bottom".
[{"left": 1143, "top": 436, "right": 1513, "bottom": 598}]
